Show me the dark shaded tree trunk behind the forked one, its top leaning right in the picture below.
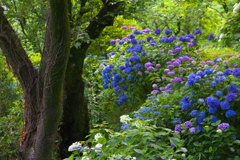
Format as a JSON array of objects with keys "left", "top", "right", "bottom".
[{"left": 60, "top": 2, "right": 123, "bottom": 158}]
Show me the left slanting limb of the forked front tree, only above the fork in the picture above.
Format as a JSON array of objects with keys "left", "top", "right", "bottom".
[{"left": 0, "top": 7, "right": 37, "bottom": 91}]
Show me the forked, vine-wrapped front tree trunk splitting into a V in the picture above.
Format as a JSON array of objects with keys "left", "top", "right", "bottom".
[{"left": 0, "top": 0, "right": 70, "bottom": 160}]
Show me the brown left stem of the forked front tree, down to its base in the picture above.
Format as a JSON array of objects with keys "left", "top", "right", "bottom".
[{"left": 0, "top": 7, "right": 38, "bottom": 159}]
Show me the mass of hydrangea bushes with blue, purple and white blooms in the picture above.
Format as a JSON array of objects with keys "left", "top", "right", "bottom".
[{"left": 66, "top": 26, "right": 240, "bottom": 160}]
